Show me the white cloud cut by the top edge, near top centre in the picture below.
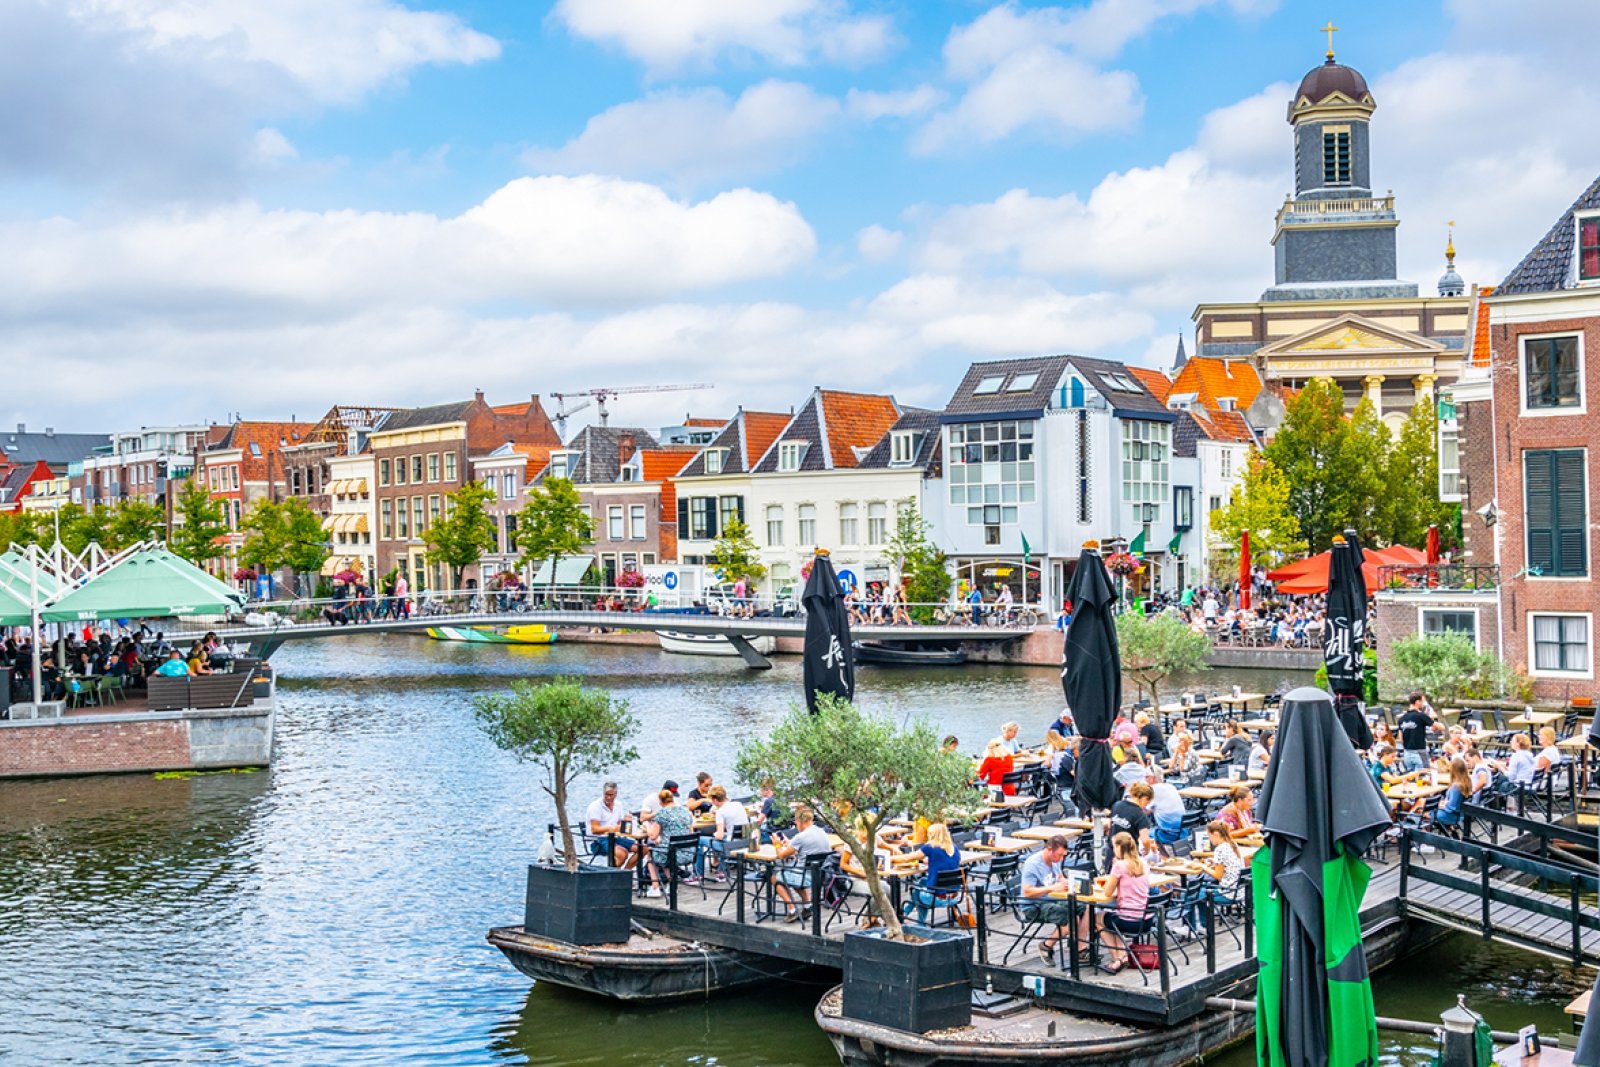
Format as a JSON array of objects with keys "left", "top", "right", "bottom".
[{"left": 550, "top": 0, "right": 894, "bottom": 72}]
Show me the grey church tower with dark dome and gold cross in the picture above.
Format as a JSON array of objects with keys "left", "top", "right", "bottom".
[{"left": 1261, "top": 34, "right": 1418, "bottom": 301}]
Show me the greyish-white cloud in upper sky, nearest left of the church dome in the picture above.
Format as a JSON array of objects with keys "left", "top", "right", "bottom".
[{"left": 912, "top": 46, "right": 1144, "bottom": 152}]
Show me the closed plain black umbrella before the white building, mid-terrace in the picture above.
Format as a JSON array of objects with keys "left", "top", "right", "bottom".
[{"left": 1061, "top": 549, "right": 1122, "bottom": 811}]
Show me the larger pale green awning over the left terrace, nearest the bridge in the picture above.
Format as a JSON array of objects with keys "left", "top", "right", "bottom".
[{"left": 40, "top": 549, "right": 245, "bottom": 622}]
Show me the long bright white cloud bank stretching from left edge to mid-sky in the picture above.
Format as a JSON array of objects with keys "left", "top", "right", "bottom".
[{"left": 0, "top": 176, "right": 816, "bottom": 313}]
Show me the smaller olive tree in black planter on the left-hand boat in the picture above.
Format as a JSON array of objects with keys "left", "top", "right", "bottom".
[{"left": 472, "top": 678, "right": 638, "bottom": 945}]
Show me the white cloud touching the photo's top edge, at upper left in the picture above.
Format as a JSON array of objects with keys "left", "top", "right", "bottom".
[{"left": 69, "top": 0, "right": 499, "bottom": 102}]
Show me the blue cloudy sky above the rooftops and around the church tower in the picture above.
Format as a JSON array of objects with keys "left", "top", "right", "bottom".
[{"left": 0, "top": 0, "right": 1600, "bottom": 432}]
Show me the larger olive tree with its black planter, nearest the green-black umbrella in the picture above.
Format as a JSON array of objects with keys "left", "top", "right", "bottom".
[{"left": 738, "top": 694, "right": 981, "bottom": 1032}]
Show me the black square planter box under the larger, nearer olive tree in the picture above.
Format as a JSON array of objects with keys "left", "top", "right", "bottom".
[{"left": 843, "top": 925, "right": 973, "bottom": 1033}]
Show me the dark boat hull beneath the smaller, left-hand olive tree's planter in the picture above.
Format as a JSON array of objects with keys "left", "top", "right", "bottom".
[{"left": 488, "top": 926, "right": 838, "bottom": 1003}]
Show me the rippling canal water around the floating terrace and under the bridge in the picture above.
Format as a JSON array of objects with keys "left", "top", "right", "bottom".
[{"left": 0, "top": 637, "right": 1579, "bottom": 1067}]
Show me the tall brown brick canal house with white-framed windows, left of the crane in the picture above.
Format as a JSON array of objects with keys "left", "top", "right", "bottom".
[{"left": 368, "top": 392, "right": 562, "bottom": 590}]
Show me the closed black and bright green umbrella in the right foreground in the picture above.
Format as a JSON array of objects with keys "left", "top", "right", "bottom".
[{"left": 1250, "top": 688, "right": 1390, "bottom": 1067}]
